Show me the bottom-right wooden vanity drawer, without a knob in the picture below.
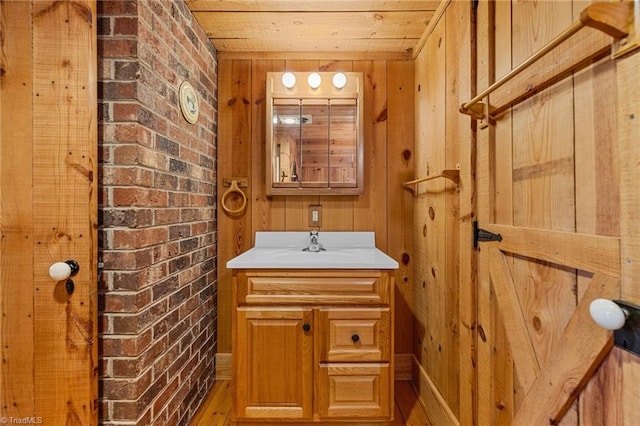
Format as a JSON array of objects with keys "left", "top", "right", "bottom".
[{"left": 318, "top": 363, "right": 393, "bottom": 418}]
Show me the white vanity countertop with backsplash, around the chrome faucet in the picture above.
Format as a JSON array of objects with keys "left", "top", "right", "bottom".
[{"left": 227, "top": 232, "right": 398, "bottom": 269}]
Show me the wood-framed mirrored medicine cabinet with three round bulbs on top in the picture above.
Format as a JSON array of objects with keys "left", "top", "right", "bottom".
[{"left": 266, "top": 72, "right": 363, "bottom": 195}]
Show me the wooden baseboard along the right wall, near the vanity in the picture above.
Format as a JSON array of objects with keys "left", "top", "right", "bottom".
[{"left": 411, "top": 355, "right": 460, "bottom": 426}]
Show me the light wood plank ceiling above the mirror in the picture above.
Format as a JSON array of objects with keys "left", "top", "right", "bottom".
[{"left": 186, "top": 0, "right": 440, "bottom": 58}]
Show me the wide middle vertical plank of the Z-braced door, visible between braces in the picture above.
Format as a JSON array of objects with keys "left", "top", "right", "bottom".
[{"left": 511, "top": 2, "right": 576, "bottom": 424}]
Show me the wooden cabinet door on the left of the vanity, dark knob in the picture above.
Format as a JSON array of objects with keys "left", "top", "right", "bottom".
[{"left": 234, "top": 307, "right": 314, "bottom": 419}]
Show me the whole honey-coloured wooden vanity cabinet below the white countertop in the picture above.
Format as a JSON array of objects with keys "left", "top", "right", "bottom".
[{"left": 232, "top": 269, "right": 394, "bottom": 425}]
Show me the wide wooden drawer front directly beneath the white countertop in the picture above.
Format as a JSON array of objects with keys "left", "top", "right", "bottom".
[{"left": 235, "top": 270, "right": 390, "bottom": 305}]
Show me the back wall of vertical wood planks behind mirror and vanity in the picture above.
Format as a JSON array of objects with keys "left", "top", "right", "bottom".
[{"left": 217, "top": 54, "right": 414, "bottom": 353}]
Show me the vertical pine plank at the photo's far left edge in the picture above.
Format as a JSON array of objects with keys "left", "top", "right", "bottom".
[{"left": 0, "top": 2, "right": 36, "bottom": 418}]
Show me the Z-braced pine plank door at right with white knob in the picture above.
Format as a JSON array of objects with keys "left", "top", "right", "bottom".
[{"left": 477, "top": 2, "right": 640, "bottom": 425}]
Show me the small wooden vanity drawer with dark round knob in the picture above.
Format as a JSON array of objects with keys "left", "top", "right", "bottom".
[{"left": 317, "top": 308, "right": 391, "bottom": 362}]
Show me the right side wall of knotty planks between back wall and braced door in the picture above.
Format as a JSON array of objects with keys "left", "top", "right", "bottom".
[{"left": 413, "top": 1, "right": 475, "bottom": 425}]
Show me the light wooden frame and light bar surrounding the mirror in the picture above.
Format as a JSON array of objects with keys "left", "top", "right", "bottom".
[{"left": 265, "top": 71, "right": 364, "bottom": 196}]
